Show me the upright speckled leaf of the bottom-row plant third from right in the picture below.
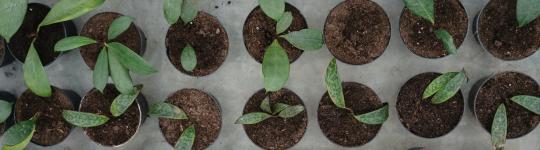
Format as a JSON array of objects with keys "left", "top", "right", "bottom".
[{"left": 324, "top": 58, "right": 346, "bottom": 108}]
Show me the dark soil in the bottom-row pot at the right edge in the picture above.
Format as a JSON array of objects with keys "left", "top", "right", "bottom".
[{"left": 474, "top": 72, "right": 540, "bottom": 138}]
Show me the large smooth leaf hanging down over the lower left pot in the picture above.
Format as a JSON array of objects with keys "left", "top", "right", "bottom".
[{"left": 23, "top": 44, "right": 52, "bottom": 97}]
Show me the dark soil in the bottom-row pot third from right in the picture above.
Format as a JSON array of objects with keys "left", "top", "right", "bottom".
[{"left": 317, "top": 82, "right": 383, "bottom": 147}]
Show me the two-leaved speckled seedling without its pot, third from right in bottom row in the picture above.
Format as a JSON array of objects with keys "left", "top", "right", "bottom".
[{"left": 325, "top": 58, "right": 388, "bottom": 125}]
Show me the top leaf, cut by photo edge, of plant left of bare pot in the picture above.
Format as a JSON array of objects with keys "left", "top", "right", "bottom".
[{"left": 259, "top": 0, "right": 285, "bottom": 21}]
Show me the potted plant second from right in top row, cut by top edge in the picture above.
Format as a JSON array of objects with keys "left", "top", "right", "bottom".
[{"left": 399, "top": 0, "right": 469, "bottom": 58}]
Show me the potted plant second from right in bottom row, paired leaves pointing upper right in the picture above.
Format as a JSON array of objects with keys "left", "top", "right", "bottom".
[{"left": 396, "top": 71, "right": 467, "bottom": 138}]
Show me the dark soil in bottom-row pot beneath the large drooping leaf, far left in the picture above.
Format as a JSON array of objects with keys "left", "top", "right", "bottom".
[{"left": 14, "top": 88, "right": 75, "bottom": 146}]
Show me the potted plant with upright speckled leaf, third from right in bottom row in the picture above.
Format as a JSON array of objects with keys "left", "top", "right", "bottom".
[{"left": 317, "top": 58, "right": 388, "bottom": 147}]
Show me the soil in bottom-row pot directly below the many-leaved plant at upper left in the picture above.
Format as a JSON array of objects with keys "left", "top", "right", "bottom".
[{"left": 80, "top": 84, "right": 142, "bottom": 146}]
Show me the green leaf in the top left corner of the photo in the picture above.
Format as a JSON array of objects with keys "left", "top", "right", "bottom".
[{"left": 0, "top": 0, "right": 28, "bottom": 42}]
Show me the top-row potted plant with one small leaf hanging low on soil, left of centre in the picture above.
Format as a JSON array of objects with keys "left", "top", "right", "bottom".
[{"left": 163, "top": 0, "right": 229, "bottom": 77}]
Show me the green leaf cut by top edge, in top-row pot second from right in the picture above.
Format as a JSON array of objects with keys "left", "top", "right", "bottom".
[{"left": 403, "top": 0, "right": 435, "bottom": 24}]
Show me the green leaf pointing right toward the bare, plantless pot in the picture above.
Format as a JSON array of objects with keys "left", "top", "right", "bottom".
[{"left": 280, "top": 29, "right": 323, "bottom": 51}]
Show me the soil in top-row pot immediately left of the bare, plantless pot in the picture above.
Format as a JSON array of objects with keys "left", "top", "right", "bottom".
[{"left": 244, "top": 3, "right": 308, "bottom": 63}]
